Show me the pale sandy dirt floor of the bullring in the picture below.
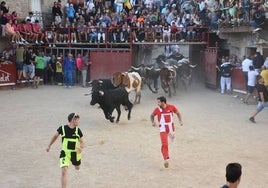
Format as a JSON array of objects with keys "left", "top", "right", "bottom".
[{"left": 0, "top": 80, "right": 268, "bottom": 188}]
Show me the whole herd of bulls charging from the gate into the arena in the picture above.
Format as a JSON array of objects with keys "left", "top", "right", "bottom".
[{"left": 89, "top": 54, "right": 196, "bottom": 122}]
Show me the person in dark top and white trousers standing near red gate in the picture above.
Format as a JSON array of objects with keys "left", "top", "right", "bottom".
[{"left": 218, "top": 57, "right": 233, "bottom": 94}]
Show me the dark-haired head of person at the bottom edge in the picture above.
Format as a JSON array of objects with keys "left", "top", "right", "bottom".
[{"left": 221, "top": 163, "right": 242, "bottom": 188}]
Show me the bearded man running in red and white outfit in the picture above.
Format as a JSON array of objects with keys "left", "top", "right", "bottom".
[{"left": 150, "top": 96, "right": 183, "bottom": 168}]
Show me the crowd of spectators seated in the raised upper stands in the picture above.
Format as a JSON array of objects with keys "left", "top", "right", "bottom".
[{"left": 0, "top": 0, "right": 267, "bottom": 46}]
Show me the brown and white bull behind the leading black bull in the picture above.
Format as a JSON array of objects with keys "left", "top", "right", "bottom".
[{"left": 113, "top": 72, "right": 142, "bottom": 104}]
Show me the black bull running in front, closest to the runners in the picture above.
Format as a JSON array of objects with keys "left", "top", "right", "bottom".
[{"left": 90, "top": 88, "right": 133, "bottom": 123}]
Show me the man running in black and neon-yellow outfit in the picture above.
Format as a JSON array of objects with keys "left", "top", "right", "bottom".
[{"left": 46, "top": 113, "right": 85, "bottom": 188}]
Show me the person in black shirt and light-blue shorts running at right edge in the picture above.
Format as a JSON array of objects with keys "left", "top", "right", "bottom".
[{"left": 249, "top": 75, "right": 268, "bottom": 123}]
